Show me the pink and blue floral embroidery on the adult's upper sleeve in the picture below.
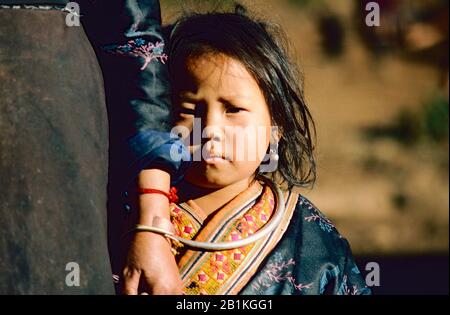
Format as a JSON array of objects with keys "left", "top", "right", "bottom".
[{"left": 104, "top": 38, "right": 168, "bottom": 70}]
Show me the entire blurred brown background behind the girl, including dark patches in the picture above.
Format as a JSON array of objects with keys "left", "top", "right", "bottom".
[{"left": 161, "top": 0, "right": 449, "bottom": 294}]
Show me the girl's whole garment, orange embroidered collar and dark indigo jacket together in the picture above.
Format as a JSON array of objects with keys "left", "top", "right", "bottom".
[{"left": 171, "top": 183, "right": 370, "bottom": 295}]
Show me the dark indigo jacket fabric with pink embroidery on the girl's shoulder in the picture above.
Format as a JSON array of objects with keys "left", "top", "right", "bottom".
[{"left": 239, "top": 196, "right": 371, "bottom": 295}]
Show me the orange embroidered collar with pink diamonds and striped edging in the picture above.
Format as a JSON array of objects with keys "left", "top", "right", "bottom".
[{"left": 171, "top": 183, "right": 297, "bottom": 294}]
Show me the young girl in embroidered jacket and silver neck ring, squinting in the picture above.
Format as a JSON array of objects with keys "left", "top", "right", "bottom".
[{"left": 122, "top": 7, "right": 370, "bottom": 294}]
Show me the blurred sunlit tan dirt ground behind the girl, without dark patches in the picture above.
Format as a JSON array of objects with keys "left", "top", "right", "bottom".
[{"left": 162, "top": 0, "right": 449, "bottom": 255}]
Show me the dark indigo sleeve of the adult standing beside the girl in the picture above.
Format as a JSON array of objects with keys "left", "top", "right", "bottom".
[{"left": 80, "top": 0, "right": 188, "bottom": 194}]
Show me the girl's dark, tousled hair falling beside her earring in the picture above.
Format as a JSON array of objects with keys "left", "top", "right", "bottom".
[{"left": 168, "top": 5, "right": 316, "bottom": 188}]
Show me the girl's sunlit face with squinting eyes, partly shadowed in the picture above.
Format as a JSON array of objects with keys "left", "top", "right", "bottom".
[{"left": 173, "top": 54, "right": 271, "bottom": 188}]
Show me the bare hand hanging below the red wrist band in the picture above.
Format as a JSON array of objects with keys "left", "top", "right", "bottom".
[{"left": 122, "top": 232, "right": 183, "bottom": 295}]
